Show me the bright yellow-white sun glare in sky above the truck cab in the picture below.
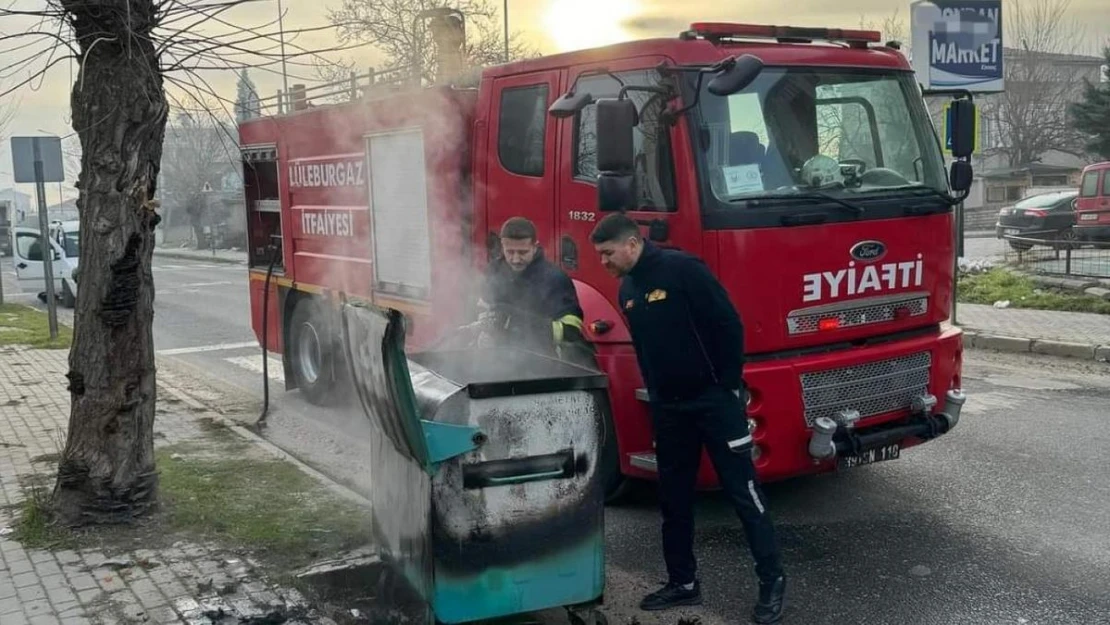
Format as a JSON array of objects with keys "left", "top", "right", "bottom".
[{"left": 544, "top": 0, "right": 637, "bottom": 52}]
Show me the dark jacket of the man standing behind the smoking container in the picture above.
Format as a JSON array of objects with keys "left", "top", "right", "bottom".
[{"left": 482, "top": 250, "right": 582, "bottom": 352}]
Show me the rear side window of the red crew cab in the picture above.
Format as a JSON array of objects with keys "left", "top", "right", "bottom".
[{"left": 497, "top": 83, "right": 547, "bottom": 178}]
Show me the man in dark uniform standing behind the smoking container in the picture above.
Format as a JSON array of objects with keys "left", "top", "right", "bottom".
[{"left": 480, "top": 216, "right": 596, "bottom": 367}]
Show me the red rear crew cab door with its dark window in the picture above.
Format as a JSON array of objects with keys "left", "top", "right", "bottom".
[{"left": 486, "top": 70, "right": 563, "bottom": 260}]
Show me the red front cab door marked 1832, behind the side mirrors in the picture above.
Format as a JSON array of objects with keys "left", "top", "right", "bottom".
[{"left": 555, "top": 57, "right": 702, "bottom": 284}]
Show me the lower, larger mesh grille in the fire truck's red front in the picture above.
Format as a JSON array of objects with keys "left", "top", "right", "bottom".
[{"left": 801, "top": 352, "right": 932, "bottom": 426}]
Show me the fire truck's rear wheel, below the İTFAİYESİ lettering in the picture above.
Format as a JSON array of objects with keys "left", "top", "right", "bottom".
[{"left": 290, "top": 300, "right": 339, "bottom": 405}]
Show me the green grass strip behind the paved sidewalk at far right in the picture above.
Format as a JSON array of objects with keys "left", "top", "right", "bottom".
[{"left": 957, "top": 269, "right": 1110, "bottom": 314}]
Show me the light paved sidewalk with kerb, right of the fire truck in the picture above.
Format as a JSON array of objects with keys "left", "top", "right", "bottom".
[{"left": 956, "top": 304, "right": 1110, "bottom": 346}]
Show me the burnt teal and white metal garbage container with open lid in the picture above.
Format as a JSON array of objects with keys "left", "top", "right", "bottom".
[{"left": 343, "top": 304, "right": 608, "bottom": 624}]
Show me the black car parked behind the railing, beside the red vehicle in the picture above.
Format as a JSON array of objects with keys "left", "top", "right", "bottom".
[{"left": 995, "top": 190, "right": 1079, "bottom": 250}]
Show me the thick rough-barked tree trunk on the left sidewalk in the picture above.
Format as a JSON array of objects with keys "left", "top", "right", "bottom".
[{"left": 53, "top": 0, "right": 169, "bottom": 525}]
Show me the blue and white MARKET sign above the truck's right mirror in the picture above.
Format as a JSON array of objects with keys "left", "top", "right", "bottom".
[{"left": 910, "top": 0, "right": 1006, "bottom": 93}]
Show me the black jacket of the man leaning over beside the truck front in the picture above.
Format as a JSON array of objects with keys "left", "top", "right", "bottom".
[{"left": 619, "top": 242, "right": 744, "bottom": 401}]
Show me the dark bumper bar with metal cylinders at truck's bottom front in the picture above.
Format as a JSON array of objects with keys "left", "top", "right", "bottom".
[{"left": 809, "top": 390, "right": 967, "bottom": 464}]
